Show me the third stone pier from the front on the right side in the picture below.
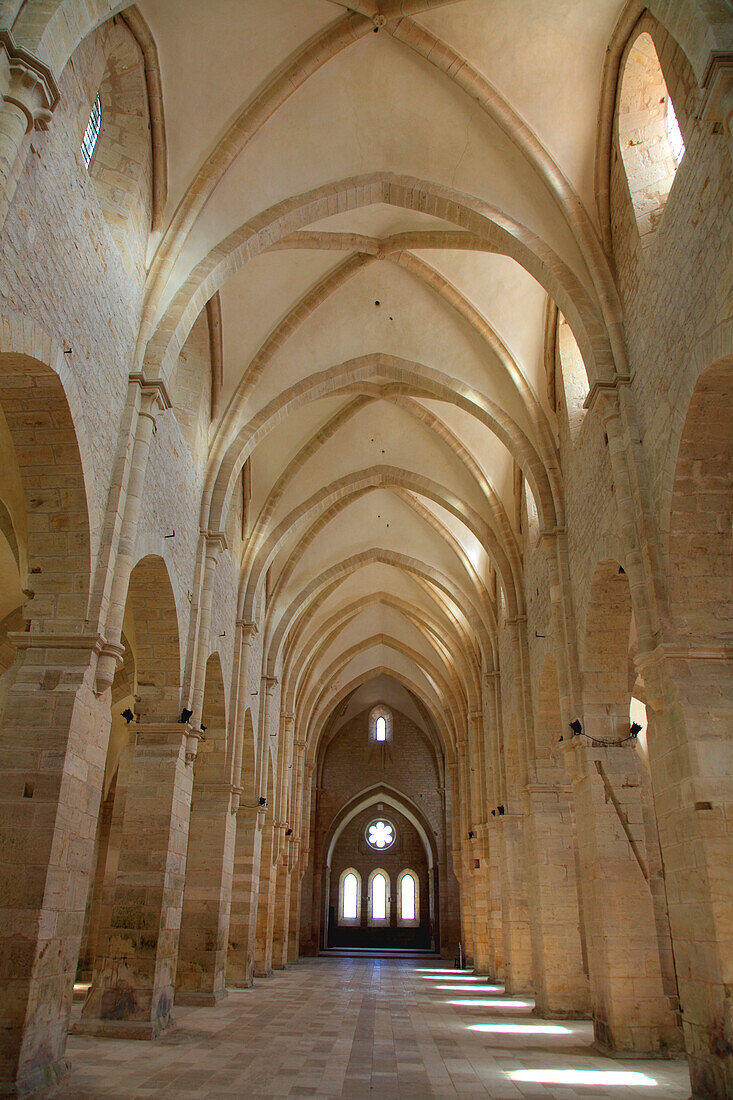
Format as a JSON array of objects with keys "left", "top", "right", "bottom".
[{"left": 525, "top": 782, "right": 590, "bottom": 1019}]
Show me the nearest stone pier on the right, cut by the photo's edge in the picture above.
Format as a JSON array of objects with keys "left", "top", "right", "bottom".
[{"left": 637, "top": 639, "right": 733, "bottom": 1100}]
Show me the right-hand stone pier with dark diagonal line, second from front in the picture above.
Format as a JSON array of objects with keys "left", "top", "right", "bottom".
[{"left": 566, "top": 734, "right": 682, "bottom": 1054}]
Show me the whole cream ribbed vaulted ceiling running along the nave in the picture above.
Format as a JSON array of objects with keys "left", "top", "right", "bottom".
[{"left": 138, "top": 0, "right": 623, "bottom": 745}]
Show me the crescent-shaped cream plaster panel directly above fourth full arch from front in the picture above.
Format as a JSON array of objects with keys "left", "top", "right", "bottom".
[{"left": 270, "top": 490, "right": 467, "bottom": 607}]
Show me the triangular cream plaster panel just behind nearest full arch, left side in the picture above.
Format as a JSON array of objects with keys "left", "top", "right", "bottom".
[{"left": 220, "top": 250, "right": 343, "bottom": 400}]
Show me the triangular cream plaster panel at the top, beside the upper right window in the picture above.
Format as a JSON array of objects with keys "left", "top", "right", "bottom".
[{"left": 417, "top": 0, "right": 624, "bottom": 218}]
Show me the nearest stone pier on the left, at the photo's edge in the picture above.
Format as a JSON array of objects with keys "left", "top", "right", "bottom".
[{"left": 0, "top": 633, "right": 110, "bottom": 1095}]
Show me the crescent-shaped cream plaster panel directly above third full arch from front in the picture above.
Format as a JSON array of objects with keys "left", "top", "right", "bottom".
[{"left": 272, "top": 402, "right": 485, "bottom": 526}]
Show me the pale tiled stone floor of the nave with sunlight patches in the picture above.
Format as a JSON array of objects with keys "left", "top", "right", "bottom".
[{"left": 58, "top": 958, "right": 690, "bottom": 1100}]
